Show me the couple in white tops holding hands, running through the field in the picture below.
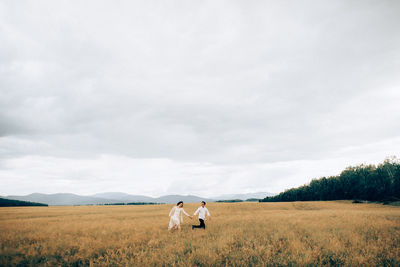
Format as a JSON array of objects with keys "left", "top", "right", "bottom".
[{"left": 168, "top": 201, "right": 211, "bottom": 230}]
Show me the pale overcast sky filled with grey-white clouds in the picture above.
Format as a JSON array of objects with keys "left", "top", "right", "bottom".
[{"left": 0, "top": 0, "right": 400, "bottom": 197}]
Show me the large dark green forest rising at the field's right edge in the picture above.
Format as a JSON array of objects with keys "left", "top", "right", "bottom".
[{"left": 260, "top": 157, "right": 400, "bottom": 202}]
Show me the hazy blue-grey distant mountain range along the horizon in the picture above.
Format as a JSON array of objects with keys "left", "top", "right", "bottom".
[{"left": 4, "top": 192, "right": 274, "bottom": 206}]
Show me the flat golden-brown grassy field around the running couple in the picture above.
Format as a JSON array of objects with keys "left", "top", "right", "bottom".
[{"left": 0, "top": 201, "right": 400, "bottom": 266}]
